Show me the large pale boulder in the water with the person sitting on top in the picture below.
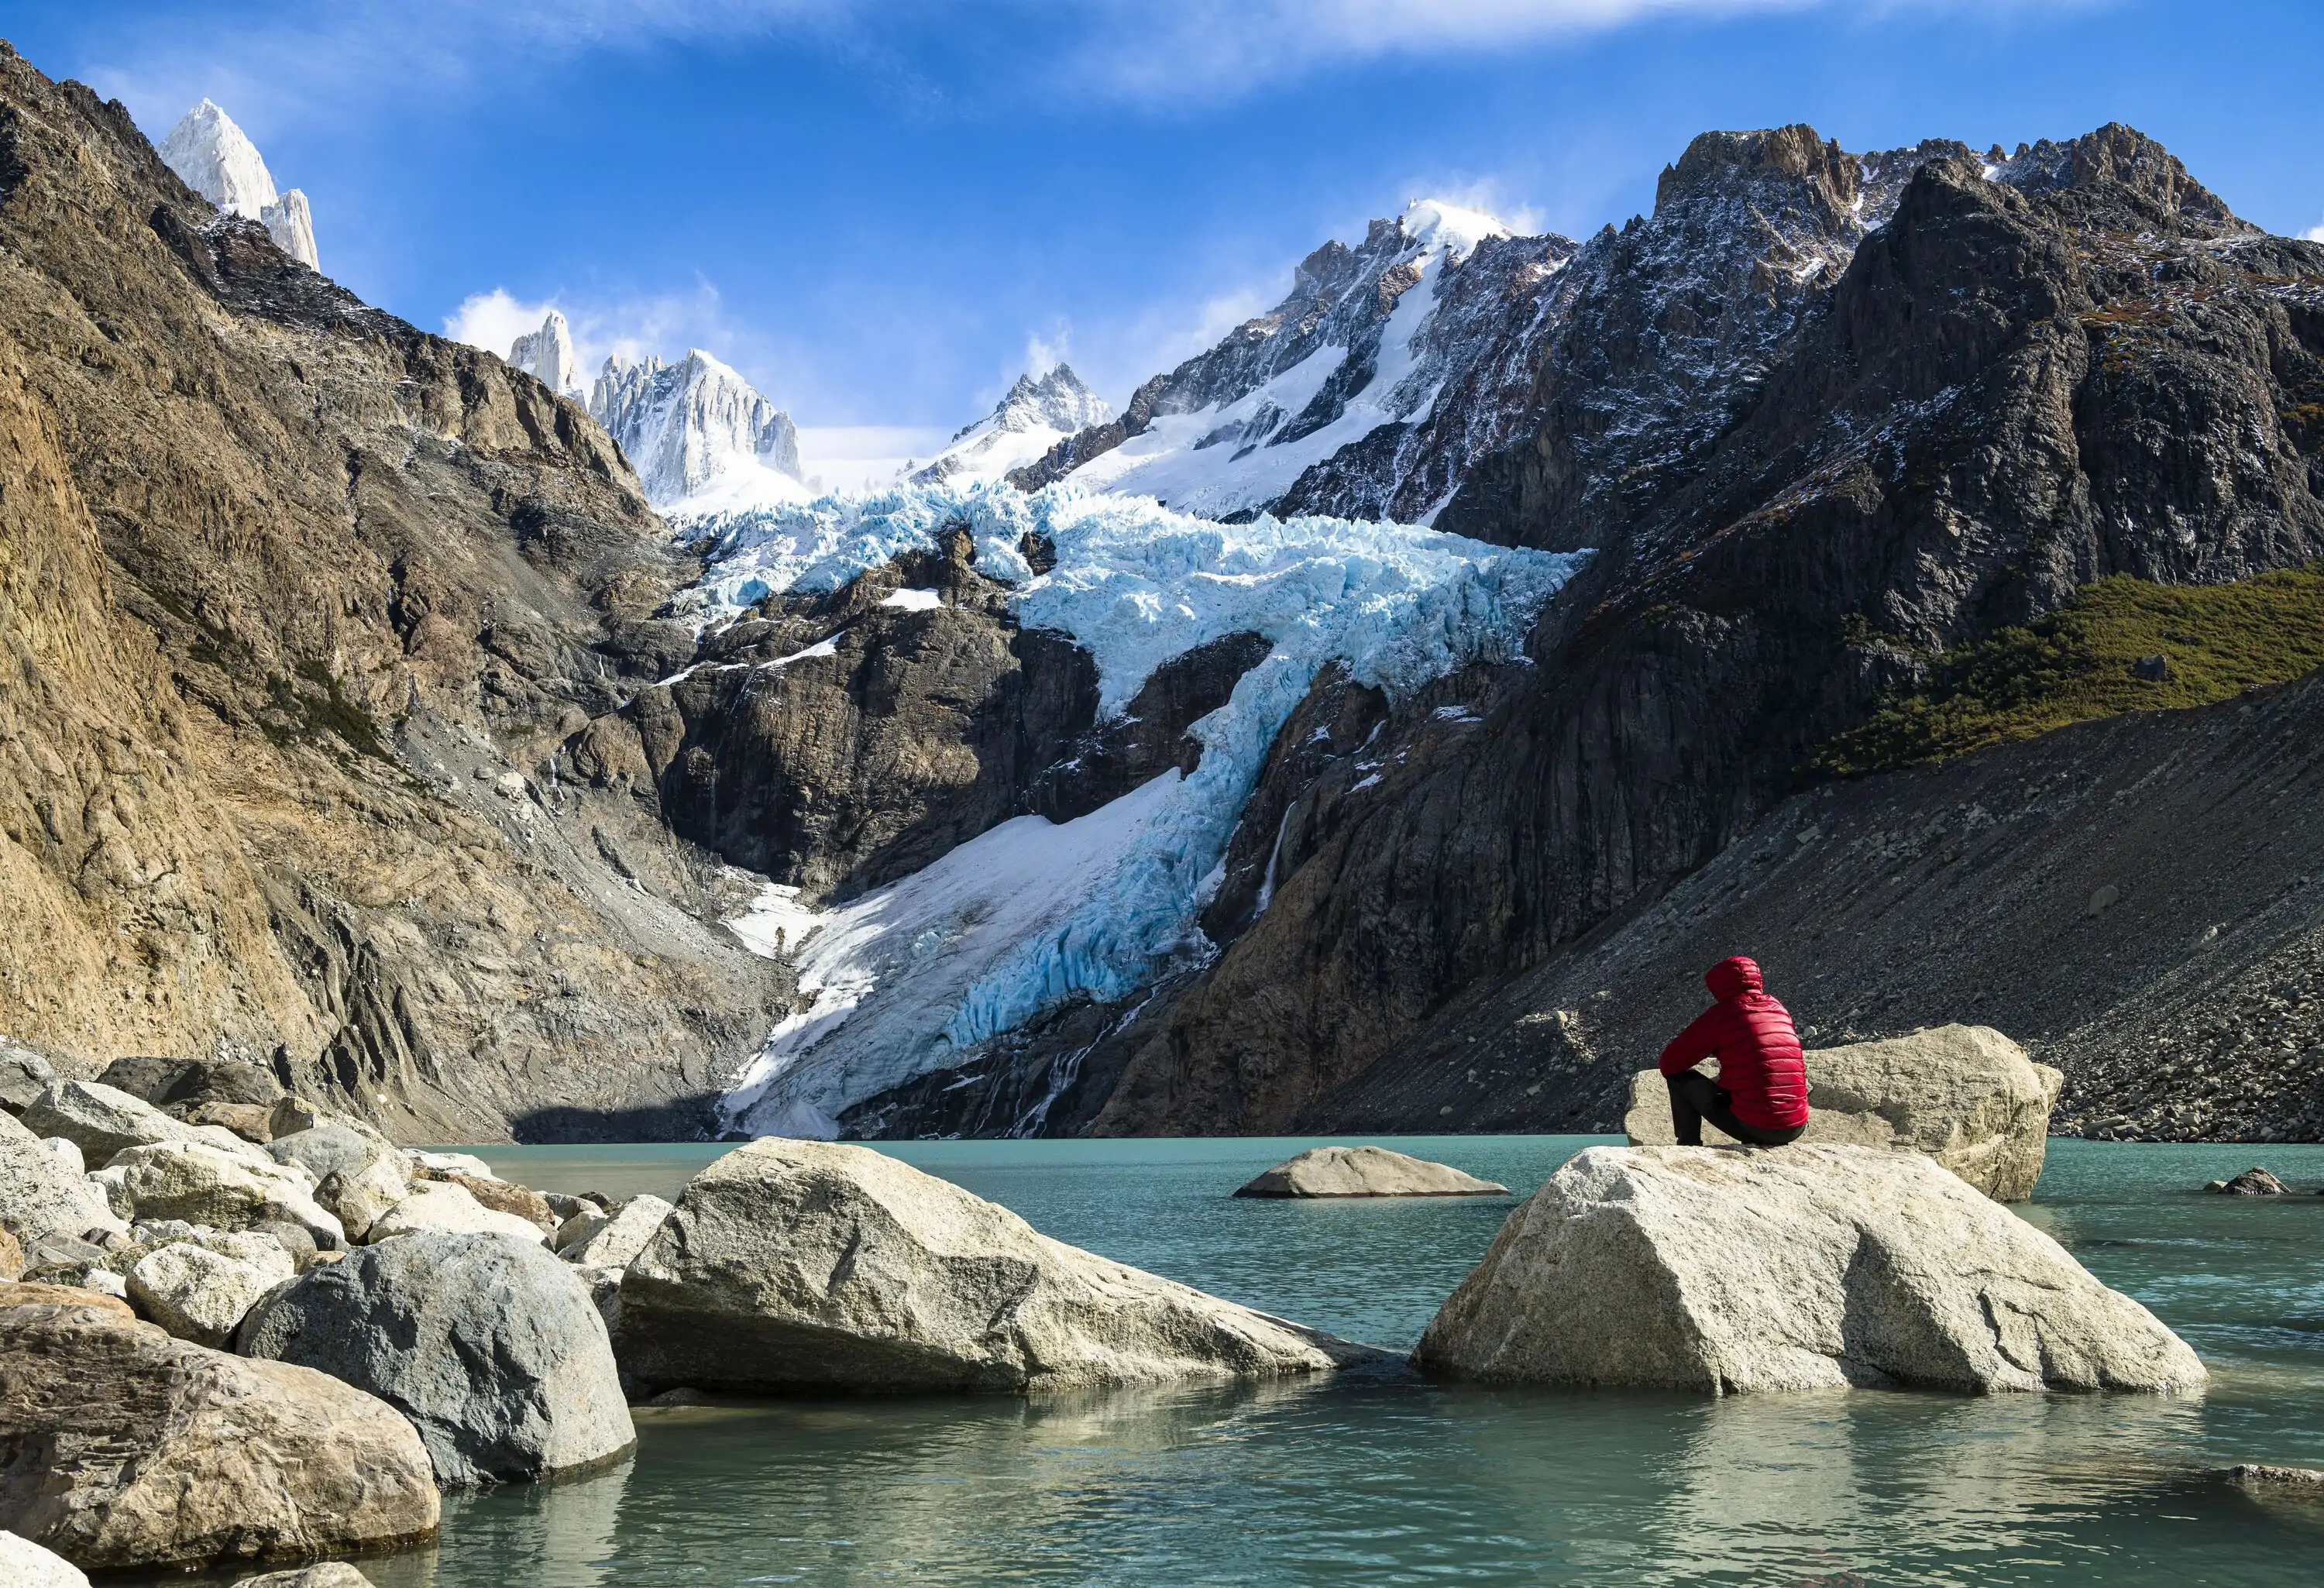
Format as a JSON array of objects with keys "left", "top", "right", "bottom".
[{"left": 1413, "top": 1146, "right": 2205, "bottom": 1395}]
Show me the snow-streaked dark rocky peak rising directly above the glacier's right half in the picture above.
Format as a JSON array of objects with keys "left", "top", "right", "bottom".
[{"left": 1011, "top": 200, "right": 1576, "bottom": 521}]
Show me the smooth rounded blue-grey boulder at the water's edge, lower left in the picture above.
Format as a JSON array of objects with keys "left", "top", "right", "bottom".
[{"left": 239, "top": 1235, "right": 637, "bottom": 1483}]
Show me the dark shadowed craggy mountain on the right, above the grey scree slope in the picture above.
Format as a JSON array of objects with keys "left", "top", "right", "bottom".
[{"left": 1074, "top": 128, "right": 2324, "bottom": 1133}]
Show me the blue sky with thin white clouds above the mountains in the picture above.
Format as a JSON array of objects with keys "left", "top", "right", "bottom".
[{"left": 0, "top": 0, "right": 2324, "bottom": 479}]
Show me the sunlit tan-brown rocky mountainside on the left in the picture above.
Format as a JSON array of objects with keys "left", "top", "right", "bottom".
[{"left": 0, "top": 46, "right": 783, "bottom": 1142}]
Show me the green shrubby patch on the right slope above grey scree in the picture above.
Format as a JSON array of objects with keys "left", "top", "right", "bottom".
[{"left": 1808, "top": 562, "right": 2324, "bottom": 776}]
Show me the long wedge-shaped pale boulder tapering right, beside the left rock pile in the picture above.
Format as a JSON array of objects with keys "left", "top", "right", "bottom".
[{"left": 616, "top": 1137, "right": 1376, "bottom": 1393}]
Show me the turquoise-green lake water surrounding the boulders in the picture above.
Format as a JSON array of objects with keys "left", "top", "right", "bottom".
[{"left": 181, "top": 1137, "right": 2324, "bottom": 1588}]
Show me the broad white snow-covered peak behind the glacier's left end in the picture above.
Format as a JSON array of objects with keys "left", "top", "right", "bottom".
[{"left": 586, "top": 346, "right": 811, "bottom": 514}]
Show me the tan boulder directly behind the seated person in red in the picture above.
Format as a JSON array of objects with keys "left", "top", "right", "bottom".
[{"left": 1622, "top": 1026, "right": 2066, "bottom": 1202}]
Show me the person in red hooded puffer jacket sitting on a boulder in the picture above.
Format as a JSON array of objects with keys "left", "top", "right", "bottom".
[{"left": 1662, "top": 954, "right": 1808, "bottom": 1146}]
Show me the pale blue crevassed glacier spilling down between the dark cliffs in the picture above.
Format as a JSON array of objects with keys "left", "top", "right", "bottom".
[{"left": 686, "top": 483, "right": 1590, "bottom": 1135}]
